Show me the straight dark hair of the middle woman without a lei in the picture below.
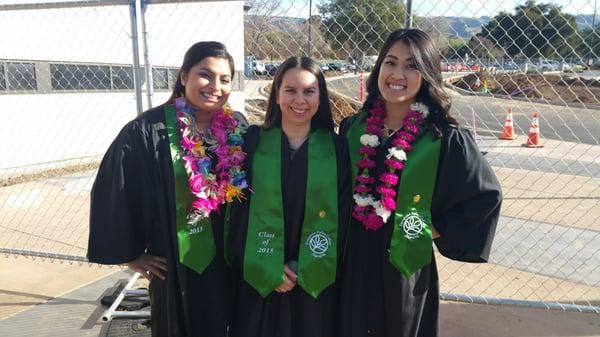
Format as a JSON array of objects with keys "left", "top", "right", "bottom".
[{"left": 263, "top": 56, "right": 333, "bottom": 131}]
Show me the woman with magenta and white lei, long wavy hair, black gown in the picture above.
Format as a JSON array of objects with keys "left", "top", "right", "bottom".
[{"left": 340, "top": 29, "right": 502, "bottom": 337}]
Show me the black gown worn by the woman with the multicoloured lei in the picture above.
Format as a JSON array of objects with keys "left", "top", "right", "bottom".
[{"left": 88, "top": 106, "right": 245, "bottom": 337}]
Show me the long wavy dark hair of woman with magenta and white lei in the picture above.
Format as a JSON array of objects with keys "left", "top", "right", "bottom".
[{"left": 363, "top": 29, "right": 458, "bottom": 136}]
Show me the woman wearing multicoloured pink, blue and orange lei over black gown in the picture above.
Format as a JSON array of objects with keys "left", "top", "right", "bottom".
[{"left": 88, "top": 42, "right": 247, "bottom": 337}]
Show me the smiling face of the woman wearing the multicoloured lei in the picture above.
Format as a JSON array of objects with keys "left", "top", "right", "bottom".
[{"left": 180, "top": 57, "right": 232, "bottom": 114}]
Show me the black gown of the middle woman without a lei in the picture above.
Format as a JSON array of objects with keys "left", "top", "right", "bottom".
[{"left": 230, "top": 127, "right": 351, "bottom": 337}]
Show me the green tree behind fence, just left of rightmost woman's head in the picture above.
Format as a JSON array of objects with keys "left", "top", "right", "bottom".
[{"left": 317, "top": 0, "right": 405, "bottom": 58}]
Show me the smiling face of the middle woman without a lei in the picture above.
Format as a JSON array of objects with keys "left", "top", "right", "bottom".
[{"left": 277, "top": 68, "right": 319, "bottom": 127}]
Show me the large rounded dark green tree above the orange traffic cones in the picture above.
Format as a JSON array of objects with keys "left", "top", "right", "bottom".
[{"left": 477, "top": 0, "right": 577, "bottom": 58}]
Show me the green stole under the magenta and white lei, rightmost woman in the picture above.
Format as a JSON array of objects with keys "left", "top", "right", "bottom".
[{"left": 347, "top": 112, "right": 441, "bottom": 278}]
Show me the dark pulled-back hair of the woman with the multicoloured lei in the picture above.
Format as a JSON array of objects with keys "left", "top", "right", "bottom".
[{"left": 166, "top": 41, "right": 235, "bottom": 104}]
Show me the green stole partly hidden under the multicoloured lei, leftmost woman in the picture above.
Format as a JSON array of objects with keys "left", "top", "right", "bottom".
[{"left": 165, "top": 105, "right": 216, "bottom": 274}]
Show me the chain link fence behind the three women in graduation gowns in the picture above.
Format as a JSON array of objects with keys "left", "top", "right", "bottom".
[{"left": 0, "top": 0, "right": 600, "bottom": 313}]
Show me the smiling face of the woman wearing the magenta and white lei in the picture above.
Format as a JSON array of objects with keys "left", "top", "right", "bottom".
[{"left": 377, "top": 41, "right": 423, "bottom": 105}]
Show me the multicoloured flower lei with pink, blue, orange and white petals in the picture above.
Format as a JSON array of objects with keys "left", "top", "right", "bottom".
[{"left": 175, "top": 97, "right": 248, "bottom": 224}]
